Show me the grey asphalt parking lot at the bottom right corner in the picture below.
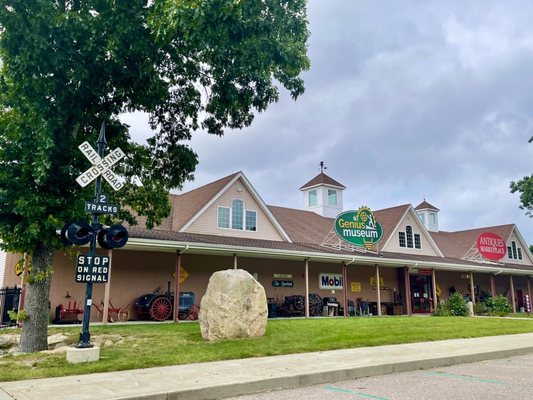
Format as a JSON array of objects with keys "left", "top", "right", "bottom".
[{"left": 227, "top": 354, "right": 533, "bottom": 400}]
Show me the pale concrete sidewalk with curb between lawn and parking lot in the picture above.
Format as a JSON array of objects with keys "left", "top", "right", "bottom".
[{"left": 0, "top": 333, "right": 533, "bottom": 400}]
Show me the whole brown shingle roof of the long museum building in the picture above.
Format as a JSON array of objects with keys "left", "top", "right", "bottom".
[{"left": 123, "top": 172, "right": 533, "bottom": 271}]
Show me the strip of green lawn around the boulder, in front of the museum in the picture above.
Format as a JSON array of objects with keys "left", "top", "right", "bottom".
[{"left": 0, "top": 317, "right": 533, "bottom": 381}]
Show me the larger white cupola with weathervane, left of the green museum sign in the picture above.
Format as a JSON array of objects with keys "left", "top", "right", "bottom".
[{"left": 300, "top": 168, "right": 346, "bottom": 218}]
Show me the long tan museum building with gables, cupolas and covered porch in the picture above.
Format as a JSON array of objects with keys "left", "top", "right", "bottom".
[{"left": 3, "top": 172, "right": 533, "bottom": 321}]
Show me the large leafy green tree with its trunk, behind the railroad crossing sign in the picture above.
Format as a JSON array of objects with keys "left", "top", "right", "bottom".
[{"left": 0, "top": 0, "right": 309, "bottom": 352}]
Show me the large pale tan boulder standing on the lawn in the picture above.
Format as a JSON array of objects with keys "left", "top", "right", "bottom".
[{"left": 199, "top": 269, "right": 268, "bottom": 341}]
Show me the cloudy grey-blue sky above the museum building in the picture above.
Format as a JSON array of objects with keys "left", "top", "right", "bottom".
[{"left": 122, "top": 0, "right": 533, "bottom": 244}]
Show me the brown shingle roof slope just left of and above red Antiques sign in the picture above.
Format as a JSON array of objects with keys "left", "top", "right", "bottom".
[{"left": 430, "top": 224, "right": 514, "bottom": 258}]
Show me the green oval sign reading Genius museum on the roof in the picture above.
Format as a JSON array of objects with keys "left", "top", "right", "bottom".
[{"left": 334, "top": 207, "right": 383, "bottom": 250}]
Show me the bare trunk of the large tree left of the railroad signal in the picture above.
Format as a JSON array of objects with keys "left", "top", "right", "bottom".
[{"left": 19, "top": 245, "right": 54, "bottom": 353}]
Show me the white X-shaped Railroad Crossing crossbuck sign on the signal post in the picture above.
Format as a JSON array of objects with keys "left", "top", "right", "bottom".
[{"left": 76, "top": 142, "right": 126, "bottom": 190}]
